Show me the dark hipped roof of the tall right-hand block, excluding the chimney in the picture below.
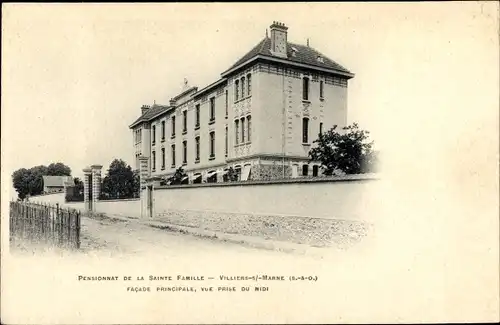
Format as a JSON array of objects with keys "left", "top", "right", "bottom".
[{"left": 223, "top": 37, "right": 351, "bottom": 74}]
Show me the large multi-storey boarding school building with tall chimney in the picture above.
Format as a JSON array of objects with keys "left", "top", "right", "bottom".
[{"left": 130, "top": 22, "right": 354, "bottom": 183}]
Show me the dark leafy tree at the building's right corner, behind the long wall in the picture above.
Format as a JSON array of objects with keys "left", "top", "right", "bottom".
[{"left": 309, "top": 123, "right": 378, "bottom": 175}]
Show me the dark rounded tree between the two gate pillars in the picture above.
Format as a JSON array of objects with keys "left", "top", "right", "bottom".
[{"left": 102, "top": 159, "right": 137, "bottom": 199}]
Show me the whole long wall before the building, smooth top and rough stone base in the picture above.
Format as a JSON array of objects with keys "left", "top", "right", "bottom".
[{"left": 154, "top": 175, "right": 383, "bottom": 247}]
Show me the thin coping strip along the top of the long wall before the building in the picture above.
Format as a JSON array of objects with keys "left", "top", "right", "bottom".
[{"left": 154, "top": 174, "right": 380, "bottom": 190}]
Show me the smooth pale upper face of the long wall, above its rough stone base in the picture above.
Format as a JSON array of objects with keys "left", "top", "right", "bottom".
[{"left": 154, "top": 175, "right": 378, "bottom": 220}]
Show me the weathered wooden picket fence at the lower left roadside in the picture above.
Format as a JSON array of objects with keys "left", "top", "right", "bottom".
[{"left": 10, "top": 202, "right": 80, "bottom": 249}]
